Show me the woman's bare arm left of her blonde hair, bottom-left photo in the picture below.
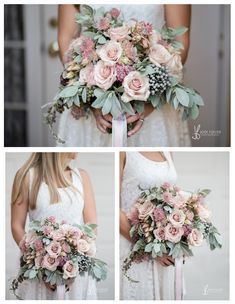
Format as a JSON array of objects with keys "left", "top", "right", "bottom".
[{"left": 11, "top": 176, "right": 29, "bottom": 246}]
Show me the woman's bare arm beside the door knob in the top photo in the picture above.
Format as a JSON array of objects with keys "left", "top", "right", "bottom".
[{"left": 58, "top": 4, "right": 79, "bottom": 63}]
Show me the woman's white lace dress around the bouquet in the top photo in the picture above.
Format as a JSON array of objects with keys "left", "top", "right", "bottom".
[{"left": 58, "top": 5, "right": 190, "bottom": 147}]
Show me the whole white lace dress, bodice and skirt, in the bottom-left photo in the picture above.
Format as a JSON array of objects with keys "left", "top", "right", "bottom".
[{"left": 19, "top": 169, "right": 97, "bottom": 300}]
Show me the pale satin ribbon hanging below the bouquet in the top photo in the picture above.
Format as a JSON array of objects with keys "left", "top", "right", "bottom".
[{"left": 112, "top": 114, "right": 127, "bottom": 147}]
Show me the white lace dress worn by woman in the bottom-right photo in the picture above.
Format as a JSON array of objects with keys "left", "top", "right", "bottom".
[{"left": 120, "top": 152, "right": 177, "bottom": 300}]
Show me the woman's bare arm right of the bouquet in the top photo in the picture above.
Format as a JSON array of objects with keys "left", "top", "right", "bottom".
[{"left": 165, "top": 4, "right": 191, "bottom": 64}]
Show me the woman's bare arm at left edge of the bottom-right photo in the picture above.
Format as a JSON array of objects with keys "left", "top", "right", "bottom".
[{"left": 120, "top": 152, "right": 131, "bottom": 241}]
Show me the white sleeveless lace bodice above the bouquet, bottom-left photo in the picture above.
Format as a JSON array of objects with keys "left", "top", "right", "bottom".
[{"left": 29, "top": 169, "right": 84, "bottom": 224}]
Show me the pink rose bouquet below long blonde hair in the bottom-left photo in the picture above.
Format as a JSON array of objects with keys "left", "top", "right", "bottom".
[{"left": 12, "top": 216, "right": 107, "bottom": 298}]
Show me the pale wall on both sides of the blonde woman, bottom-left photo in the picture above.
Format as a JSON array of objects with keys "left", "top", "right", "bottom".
[{"left": 6, "top": 153, "right": 114, "bottom": 299}]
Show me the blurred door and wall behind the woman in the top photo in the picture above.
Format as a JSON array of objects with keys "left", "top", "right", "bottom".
[{"left": 4, "top": 5, "right": 230, "bottom": 147}]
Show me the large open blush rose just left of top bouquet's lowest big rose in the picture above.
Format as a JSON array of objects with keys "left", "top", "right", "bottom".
[{"left": 94, "top": 60, "right": 116, "bottom": 91}]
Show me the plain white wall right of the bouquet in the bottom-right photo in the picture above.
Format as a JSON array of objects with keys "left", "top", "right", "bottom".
[{"left": 173, "top": 152, "right": 229, "bottom": 300}]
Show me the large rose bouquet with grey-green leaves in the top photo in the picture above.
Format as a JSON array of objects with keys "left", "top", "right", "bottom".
[{"left": 45, "top": 5, "right": 204, "bottom": 142}]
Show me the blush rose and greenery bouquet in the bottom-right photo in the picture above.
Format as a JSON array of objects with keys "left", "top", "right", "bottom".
[{"left": 123, "top": 183, "right": 222, "bottom": 282}]
